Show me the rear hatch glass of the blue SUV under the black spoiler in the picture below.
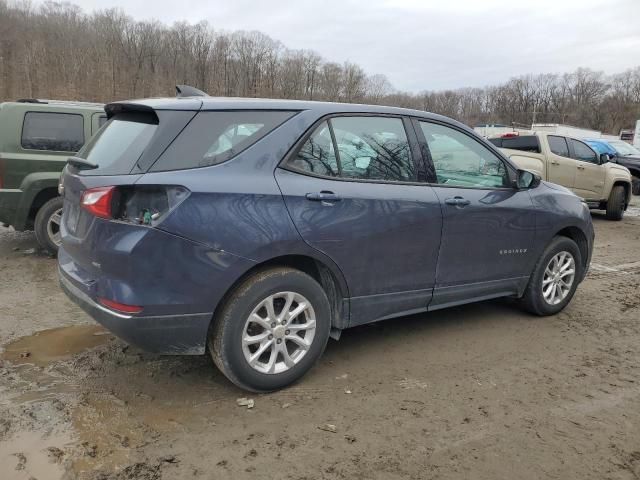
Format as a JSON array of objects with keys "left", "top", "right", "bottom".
[{"left": 78, "top": 113, "right": 158, "bottom": 175}]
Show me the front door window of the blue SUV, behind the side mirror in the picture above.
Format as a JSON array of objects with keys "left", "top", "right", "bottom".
[{"left": 420, "top": 122, "right": 509, "bottom": 188}]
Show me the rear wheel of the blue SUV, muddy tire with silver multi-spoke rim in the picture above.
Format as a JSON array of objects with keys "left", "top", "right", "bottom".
[{"left": 209, "top": 267, "right": 331, "bottom": 392}]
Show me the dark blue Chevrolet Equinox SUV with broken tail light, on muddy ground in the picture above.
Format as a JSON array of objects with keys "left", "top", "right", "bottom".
[{"left": 58, "top": 97, "right": 594, "bottom": 391}]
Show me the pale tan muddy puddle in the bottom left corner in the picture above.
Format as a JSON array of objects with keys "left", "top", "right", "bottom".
[{"left": 0, "top": 432, "right": 72, "bottom": 480}]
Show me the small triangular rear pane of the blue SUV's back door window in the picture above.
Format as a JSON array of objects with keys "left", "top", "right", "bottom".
[{"left": 289, "top": 122, "right": 338, "bottom": 177}]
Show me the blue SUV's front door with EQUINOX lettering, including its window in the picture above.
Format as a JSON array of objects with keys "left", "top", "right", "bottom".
[{"left": 418, "top": 121, "right": 535, "bottom": 309}]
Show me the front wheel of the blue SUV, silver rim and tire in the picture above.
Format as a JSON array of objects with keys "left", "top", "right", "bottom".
[{"left": 520, "top": 237, "right": 582, "bottom": 316}]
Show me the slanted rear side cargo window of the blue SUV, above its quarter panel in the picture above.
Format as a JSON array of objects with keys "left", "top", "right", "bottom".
[{"left": 151, "top": 110, "right": 295, "bottom": 172}]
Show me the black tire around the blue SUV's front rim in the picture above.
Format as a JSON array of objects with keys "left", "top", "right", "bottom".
[{"left": 519, "top": 237, "right": 584, "bottom": 316}]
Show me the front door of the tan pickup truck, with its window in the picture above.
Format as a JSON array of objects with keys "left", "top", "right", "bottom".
[{"left": 567, "top": 138, "right": 606, "bottom": 201}]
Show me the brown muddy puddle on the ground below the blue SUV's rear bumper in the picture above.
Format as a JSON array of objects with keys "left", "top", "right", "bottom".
[{"left": 0, "top": 325, "right": 113, "bottom": 367}]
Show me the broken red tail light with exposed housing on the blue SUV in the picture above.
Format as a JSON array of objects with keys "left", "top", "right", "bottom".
[{"left": 80, "top": 185, "right": 189, "bottom": 226}]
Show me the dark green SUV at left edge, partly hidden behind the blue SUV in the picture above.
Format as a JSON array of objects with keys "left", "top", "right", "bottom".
[{"left": 0, "top": 99, "right": 107, "bottom": 254}]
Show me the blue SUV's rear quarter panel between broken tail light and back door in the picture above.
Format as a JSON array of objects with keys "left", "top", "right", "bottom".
[{"left": 136, "top": 107, "right": 348, "bottom": 305}]
